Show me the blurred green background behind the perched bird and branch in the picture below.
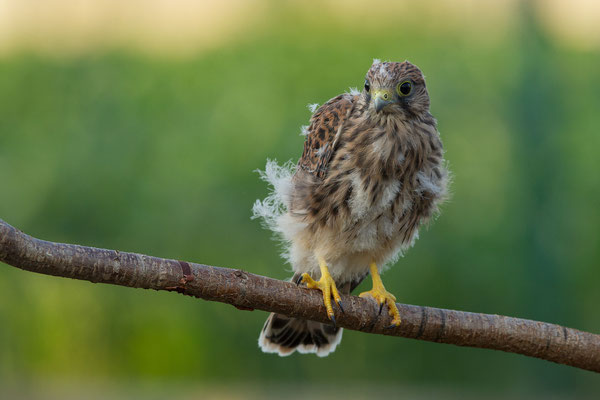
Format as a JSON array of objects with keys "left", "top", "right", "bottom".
[{"left": 0, "top": 0, "right": 600, "bottom": 399}]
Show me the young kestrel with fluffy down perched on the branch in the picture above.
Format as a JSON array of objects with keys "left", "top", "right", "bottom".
[{"left": 253, "top": 60, "right": 448, "bottom": 356}]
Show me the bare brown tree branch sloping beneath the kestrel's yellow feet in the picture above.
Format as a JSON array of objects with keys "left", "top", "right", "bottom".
[{"left": 0, "top": 219, "right": 600, "bottom": 372}]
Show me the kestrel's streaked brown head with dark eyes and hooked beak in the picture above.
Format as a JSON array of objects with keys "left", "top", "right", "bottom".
[{"left": 362, "top": 60, "right": 429, "bottom": 118}]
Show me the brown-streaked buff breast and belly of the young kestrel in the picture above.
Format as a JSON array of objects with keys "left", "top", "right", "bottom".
[{"left": 298, "top": 113, "right": 446, "bottom": 262}]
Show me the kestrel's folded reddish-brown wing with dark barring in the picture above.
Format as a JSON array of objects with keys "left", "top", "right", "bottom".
[{"left": 298, "top": 93, "right": 358, "bottom": 179}]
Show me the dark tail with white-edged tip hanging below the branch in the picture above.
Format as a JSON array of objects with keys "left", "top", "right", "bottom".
[{"left": 258, "top": 313, "right": 343, "bottom": 357}]
